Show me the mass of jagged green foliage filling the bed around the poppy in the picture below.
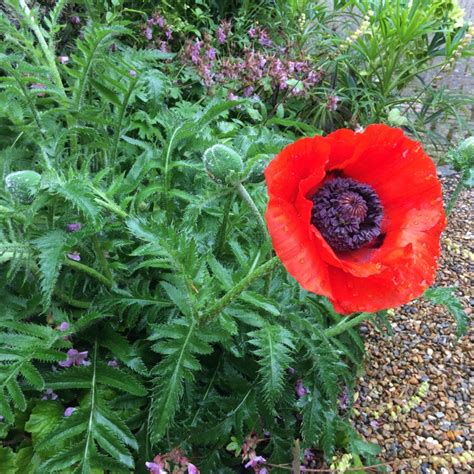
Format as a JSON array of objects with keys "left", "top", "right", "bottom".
[{"left": 0, "top": 0, "right": 462, "bottom": 473}]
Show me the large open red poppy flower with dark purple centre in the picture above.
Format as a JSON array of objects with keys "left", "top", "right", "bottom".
[{"left": 265, "top": 125, "right": 446, "bottom": 314}]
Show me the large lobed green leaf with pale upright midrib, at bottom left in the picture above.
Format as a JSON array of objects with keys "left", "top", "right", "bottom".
[{"left": 38, "top": 343, "right": 147, "bottom": 472}]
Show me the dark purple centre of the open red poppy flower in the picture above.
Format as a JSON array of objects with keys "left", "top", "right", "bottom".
[{"left": 311, "top": 178, "right": 383, "bottom": 252}]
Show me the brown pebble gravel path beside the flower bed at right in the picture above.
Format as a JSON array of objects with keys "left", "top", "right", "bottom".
[{"left": 354, "top": 176, "right": 474, "bottom": 474}]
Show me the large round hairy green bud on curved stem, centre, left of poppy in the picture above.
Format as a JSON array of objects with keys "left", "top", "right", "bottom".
[{"left": 203, "top": 144, "right": 244, "bottom": 184}]
